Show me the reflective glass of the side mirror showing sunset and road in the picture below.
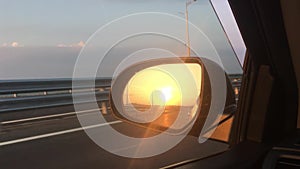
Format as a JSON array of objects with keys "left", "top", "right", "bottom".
[{"left": 122, "top": 63, "right": 202, "bottom": 130}]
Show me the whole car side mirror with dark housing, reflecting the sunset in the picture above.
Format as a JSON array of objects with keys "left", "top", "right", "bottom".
[{"left": 110, "top": 57, "right": 235, "bottom": 135}]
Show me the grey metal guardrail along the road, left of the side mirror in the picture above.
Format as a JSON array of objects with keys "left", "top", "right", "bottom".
[{"left": 0, "top": 78, "right": 111, "bottom": 113}]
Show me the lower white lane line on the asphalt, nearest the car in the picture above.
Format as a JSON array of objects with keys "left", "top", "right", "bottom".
[{"left": 0, "top": 120, "right": 122, "bottom": 147}]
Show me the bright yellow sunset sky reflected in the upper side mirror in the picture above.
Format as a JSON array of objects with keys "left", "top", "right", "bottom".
[{"left": 123, "top": 64, "right": 201, "bottom": 106}]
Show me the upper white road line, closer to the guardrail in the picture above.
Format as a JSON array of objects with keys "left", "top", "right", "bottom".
[{"left": 1, "top": 109, "right": 100, "bottom": 125}]
